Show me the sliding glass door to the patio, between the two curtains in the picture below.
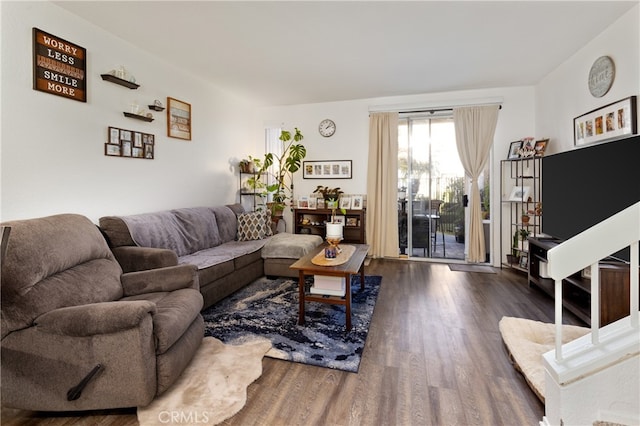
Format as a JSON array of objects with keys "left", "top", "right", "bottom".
[{"left": 398, "top": 113, "right": 465, "bottom": 260}]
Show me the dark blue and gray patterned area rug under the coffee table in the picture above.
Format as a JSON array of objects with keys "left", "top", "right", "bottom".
[{"left": 202, "top": 275, "right": 382, "bottom": 373}]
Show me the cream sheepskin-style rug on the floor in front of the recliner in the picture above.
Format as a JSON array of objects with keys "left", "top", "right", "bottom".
[{"left": 138, "top": 337, "right": 271, "bottom": 426}]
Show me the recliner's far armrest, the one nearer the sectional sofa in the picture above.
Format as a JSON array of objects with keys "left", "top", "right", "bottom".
[{"left": 120, "top": 265, "right": 200, "bottom": 296}]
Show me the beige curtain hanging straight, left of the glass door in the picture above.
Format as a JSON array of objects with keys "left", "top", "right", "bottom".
[{"left": 366, "top": 112, "right": 400, "bottom": 258}]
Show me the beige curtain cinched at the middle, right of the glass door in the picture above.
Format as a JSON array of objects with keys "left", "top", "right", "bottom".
[{"left": 453, "top": 105, "right": 499, "bottom": 263}]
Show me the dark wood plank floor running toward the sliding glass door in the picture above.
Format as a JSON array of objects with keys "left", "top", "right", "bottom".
[{"left": 2, "top": 260, "right": 583, "bottom": 425}]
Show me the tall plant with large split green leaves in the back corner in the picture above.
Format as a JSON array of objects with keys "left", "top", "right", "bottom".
[{"left": 253, "top": 127, "right": 307, "bottom": 216}]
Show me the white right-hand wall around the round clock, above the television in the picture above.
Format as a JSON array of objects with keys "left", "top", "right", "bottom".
[{"left": 536, "top": 6, "right": 640, "bottom": 153}]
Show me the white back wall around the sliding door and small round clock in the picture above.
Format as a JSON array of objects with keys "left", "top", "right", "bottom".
[{"left": 255, "top": 87, "right": 536, "bottom": 264}]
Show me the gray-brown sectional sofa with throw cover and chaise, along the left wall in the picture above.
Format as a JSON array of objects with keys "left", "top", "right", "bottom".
[{"left": 99, "top": 204, "right": 322, "bottom": 308}]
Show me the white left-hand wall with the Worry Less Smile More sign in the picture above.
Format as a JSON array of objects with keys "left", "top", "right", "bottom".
[{"left": 0, "top": 2, "right": 255, "bottom": 222}]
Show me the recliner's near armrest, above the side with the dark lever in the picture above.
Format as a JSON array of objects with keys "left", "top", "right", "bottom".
[{"left": 35, "top": 300, "right": 156, "bottom": 337}]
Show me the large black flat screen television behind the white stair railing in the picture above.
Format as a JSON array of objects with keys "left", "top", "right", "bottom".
[{"left": 542, "top": 136, "right": 640, "bottom": 262}]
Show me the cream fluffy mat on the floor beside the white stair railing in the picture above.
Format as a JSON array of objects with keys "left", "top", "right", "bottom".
[{"left": 499, "top": 317, "right": 590, "bottom": 402}]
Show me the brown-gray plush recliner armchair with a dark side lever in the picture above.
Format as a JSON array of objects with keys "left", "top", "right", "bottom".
[{"left": 1, "top": 214, "right": 204, "bottom": 411}]
